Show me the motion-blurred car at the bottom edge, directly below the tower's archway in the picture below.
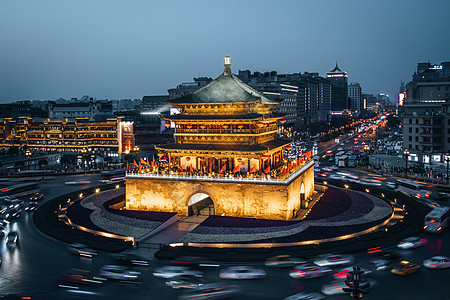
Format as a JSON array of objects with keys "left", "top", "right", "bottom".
[{"left": 178, "top": 283, "right": 241, "bottom": 300}]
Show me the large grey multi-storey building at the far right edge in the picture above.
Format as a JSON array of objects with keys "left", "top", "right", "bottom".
[{"left": 403, "top": 62, "right": 450, "bottom": 163}]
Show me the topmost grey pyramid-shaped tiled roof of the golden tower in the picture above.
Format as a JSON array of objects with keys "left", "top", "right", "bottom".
[{"left": 167, "top": 72, "right": 282, "bottom": 104}]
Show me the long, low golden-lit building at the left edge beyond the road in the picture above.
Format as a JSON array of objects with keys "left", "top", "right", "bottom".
[{"left": 0, "top": 117, "right": 134, "bottom": 153}]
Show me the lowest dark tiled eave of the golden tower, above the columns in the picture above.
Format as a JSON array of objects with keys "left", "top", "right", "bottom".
[{"left": 156, "top": 139, "right": 292, "bottom": 152}]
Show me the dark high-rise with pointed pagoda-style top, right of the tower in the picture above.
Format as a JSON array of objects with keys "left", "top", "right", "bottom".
[{"left": 327, "top": 63, "right": 351, "bottom": 111}]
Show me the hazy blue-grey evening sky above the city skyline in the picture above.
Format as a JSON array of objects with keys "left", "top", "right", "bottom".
[{"left": 0, "top": 0, "right": 450, "bottom": 102}]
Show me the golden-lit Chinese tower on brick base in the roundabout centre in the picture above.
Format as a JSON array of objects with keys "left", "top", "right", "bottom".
[{"left": 126, "top": 57, "right": 314, "bottom": 220}]
